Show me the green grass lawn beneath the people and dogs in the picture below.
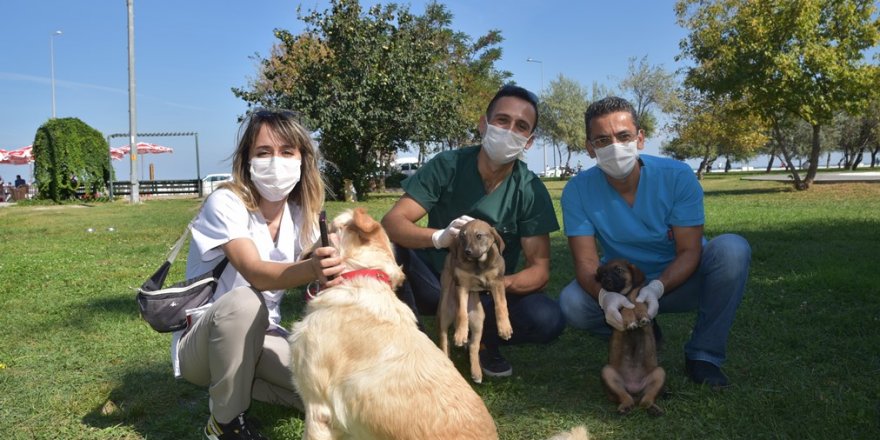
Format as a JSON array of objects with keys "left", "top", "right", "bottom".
[{"left": 0, "top": 175, "right": 880, "bottom": 440}]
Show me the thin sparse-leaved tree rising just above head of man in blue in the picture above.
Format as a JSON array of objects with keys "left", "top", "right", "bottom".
[{"left": 620, "top": 55, "right": 678, "bottom": 137}]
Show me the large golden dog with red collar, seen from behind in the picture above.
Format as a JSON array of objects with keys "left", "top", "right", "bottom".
[{"left": 290, "top": 209, "right": 498, "bottom": 440}]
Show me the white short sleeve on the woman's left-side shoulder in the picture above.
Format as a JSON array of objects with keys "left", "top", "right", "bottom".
[{"left": 190, "top": 189, "right": 251, "bottom": 261}]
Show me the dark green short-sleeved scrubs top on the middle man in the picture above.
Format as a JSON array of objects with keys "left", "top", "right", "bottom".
[{"left": 402, "top": 145, "right": 559, "bottom": 274}]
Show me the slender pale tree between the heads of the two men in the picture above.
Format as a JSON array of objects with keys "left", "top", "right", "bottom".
[{"left": 538, "top": 74, "right": 587, "bottom": 173}]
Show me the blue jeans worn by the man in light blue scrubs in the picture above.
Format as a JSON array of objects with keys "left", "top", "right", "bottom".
[{"left": 559, "top": 234, "right": 752, "bottom": 366}]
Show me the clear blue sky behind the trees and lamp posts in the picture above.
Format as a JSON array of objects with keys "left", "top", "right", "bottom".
[{"left": 0, "top": 0, "right": 686, "bottom": 181}]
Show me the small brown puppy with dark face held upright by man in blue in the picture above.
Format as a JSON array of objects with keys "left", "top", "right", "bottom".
[{"left": 596, "top": 259, "right": 666, "bottom": 416}]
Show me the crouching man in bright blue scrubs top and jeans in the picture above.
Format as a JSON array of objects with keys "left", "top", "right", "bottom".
[{"left": 559, "top": 97, "right": 751, "bottom": 388}]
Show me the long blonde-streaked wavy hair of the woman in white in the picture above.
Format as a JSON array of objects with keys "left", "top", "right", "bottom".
[{"left": 220, "top": 108, "right": 326, "bottom": 249}]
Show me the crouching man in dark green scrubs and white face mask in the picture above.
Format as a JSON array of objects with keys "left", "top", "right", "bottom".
[{"left": 382, "top": 85, "right": 565, "bottom": 377}]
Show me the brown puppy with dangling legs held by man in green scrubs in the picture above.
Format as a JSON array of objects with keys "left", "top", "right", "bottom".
[{"left": 437, "top": 220, "right": 513, "bottom": 383}]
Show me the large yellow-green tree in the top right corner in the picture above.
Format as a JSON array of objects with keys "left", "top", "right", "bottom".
[{"left": 676, "top": 0, "right": 880, "bottom": 189}]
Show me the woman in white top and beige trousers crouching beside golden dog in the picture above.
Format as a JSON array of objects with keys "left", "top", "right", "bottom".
[{"left": 172, "top": 110, "right": 342, "bottom": 439}]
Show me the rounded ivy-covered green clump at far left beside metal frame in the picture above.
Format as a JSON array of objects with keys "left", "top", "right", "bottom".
[{"left": 33, "top": 118, "right": 113, "bottom": 202}]
